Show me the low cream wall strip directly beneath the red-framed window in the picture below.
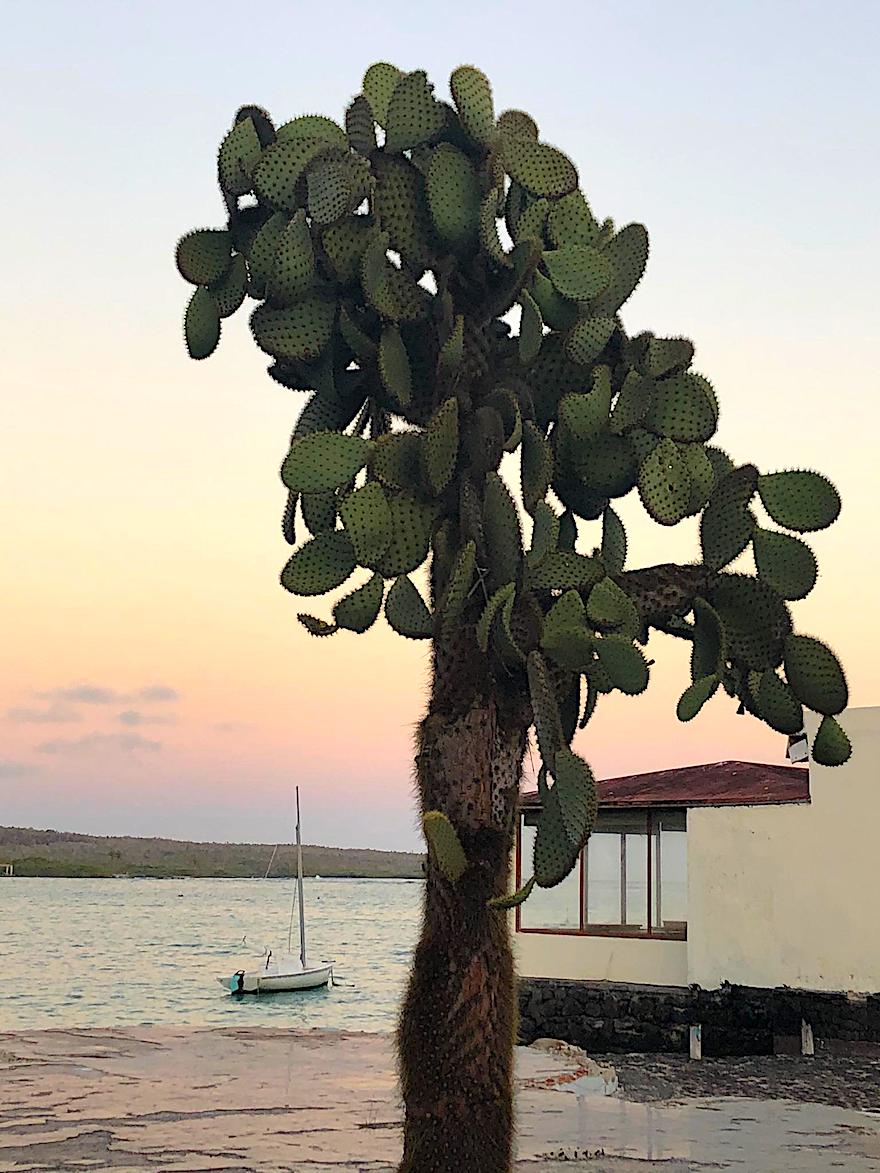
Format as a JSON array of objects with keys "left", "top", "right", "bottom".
[{"left": 514, "top": 933, "right": 688, "bottom": 985}]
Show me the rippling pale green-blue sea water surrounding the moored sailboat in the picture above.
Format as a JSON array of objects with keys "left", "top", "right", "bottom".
[{"left": 0, "top": 877, "right": 422, "bottom": 1031}]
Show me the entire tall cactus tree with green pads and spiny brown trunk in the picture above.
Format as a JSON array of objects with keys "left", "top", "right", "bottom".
[{"left": 177, "top": 63, "right": 849, "bottom": 1173}]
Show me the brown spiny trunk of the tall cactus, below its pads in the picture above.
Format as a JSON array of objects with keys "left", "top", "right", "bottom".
[{"left": 398, "top": 629, "right": 528, "bottom": 1173}]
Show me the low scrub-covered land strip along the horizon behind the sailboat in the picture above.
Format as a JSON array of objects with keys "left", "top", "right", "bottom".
[{"left": 0, "top": 827, "right": 424, "bottom": 884}]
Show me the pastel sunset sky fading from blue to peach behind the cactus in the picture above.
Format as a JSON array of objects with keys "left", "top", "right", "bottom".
[{"left": 0, "top": 0, "right": 880, "bottom": 849}]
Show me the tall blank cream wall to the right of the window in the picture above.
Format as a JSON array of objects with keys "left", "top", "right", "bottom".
[{"left": 689, "top": 708, "right": 880, "bottom": 992}]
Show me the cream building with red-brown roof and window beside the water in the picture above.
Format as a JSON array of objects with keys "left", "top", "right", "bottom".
[{"left": 515, "top": 708, "right": 880, "bottom": 994}]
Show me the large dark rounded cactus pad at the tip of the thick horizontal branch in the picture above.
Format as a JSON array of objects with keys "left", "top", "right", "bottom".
[{"left": 709, "top": 574, "right": 791, "bottom": 671}]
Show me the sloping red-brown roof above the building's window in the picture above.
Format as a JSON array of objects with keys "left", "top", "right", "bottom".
[{"left": 520, "top": 761, "right": 810, "bottom": 807}]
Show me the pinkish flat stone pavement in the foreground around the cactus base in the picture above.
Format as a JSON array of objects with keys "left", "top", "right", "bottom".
[{"left": 0, "top": 1028, "right": 880, "bottom": 1173}]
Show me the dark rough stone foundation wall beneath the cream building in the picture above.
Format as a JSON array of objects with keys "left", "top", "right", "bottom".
[{"left": 520, "top": 977, "right": 880, "bottom": 1056}]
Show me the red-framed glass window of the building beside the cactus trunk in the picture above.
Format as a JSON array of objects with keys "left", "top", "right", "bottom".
[{"left": 517, "top": 811, "right": 688, "bottom": 937}]
